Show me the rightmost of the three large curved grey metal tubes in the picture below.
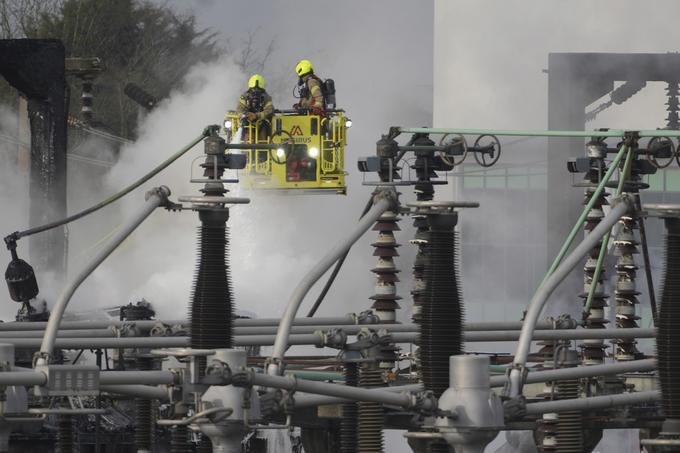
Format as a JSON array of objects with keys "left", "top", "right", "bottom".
[{"left": 508, "top": 195, "right": 635, "bottom": 397}]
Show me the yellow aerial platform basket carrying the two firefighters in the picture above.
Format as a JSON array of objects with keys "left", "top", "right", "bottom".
[{"left": 224, "top": 110, "right": 348, "bottom": 195}]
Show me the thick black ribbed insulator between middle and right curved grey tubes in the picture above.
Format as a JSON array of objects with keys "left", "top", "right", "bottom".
[{"left": 420, "top": 212, "right": 463, "bottom": 398}]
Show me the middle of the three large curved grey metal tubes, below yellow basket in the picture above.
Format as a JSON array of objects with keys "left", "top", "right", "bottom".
[{"left": 267, "top": 188, "right": 397, "bottom": 375}]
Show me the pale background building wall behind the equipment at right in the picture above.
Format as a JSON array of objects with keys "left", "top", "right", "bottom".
[{"left": 434, "top": 0, "right": 680, "bottom": 332}]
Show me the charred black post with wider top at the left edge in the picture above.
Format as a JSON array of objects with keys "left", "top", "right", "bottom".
[{"left": 0, "top": 39, "right": 68, "bottom": 276}]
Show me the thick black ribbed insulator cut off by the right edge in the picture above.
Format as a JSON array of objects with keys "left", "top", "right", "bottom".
[{"left": 656, "top": 218, "right": 680, "bottom": 435}]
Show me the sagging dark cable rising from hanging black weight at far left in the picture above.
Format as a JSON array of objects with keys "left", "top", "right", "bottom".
[{"left": 5, "top": 126, "right": 212, "bottom": 243}]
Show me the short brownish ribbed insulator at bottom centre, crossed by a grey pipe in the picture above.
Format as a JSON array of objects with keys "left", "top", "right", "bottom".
[{"left": 356, "top": 362, "right": 385, "bottom": 453}]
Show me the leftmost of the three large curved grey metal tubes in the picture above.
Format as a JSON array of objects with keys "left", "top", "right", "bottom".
[{"left": 35, "top": 186, "right": 170, "bottom": 366}]
